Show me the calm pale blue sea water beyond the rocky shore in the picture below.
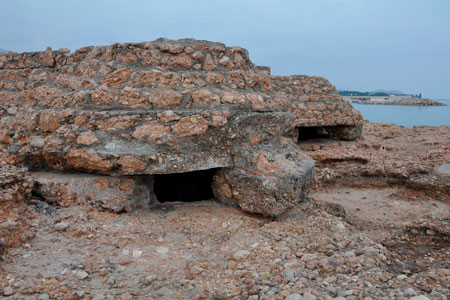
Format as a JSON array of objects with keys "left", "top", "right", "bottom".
[{"left": 352, "top": 100, "right": 450, "bottom": 128}]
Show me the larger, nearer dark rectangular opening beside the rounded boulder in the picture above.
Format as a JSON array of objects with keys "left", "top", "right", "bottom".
[{"left": 153, "top": 169, "right": 216, "bottom": 203}]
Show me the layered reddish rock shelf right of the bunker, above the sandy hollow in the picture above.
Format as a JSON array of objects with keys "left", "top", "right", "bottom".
[{"left": 298, "top": 121, "right": 450, "bottom": 201}]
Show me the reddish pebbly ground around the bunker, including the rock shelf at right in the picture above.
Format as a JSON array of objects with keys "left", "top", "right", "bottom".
[{"left": 0, "top": 123, "right": 450, "bottom": 300}]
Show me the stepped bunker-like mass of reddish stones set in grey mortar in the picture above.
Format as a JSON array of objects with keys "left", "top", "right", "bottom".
[{"left": 0, "top": 39, "right": 362, "bottom": 216}]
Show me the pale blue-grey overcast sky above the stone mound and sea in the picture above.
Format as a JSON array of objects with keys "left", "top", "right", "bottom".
[{"left": 0, "top": 0, "right": 450, "bottom": 98}]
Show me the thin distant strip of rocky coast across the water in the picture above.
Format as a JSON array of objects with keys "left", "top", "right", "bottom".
[{"left": 343, "top": 96, "right": 447, "bottom": 106}]
